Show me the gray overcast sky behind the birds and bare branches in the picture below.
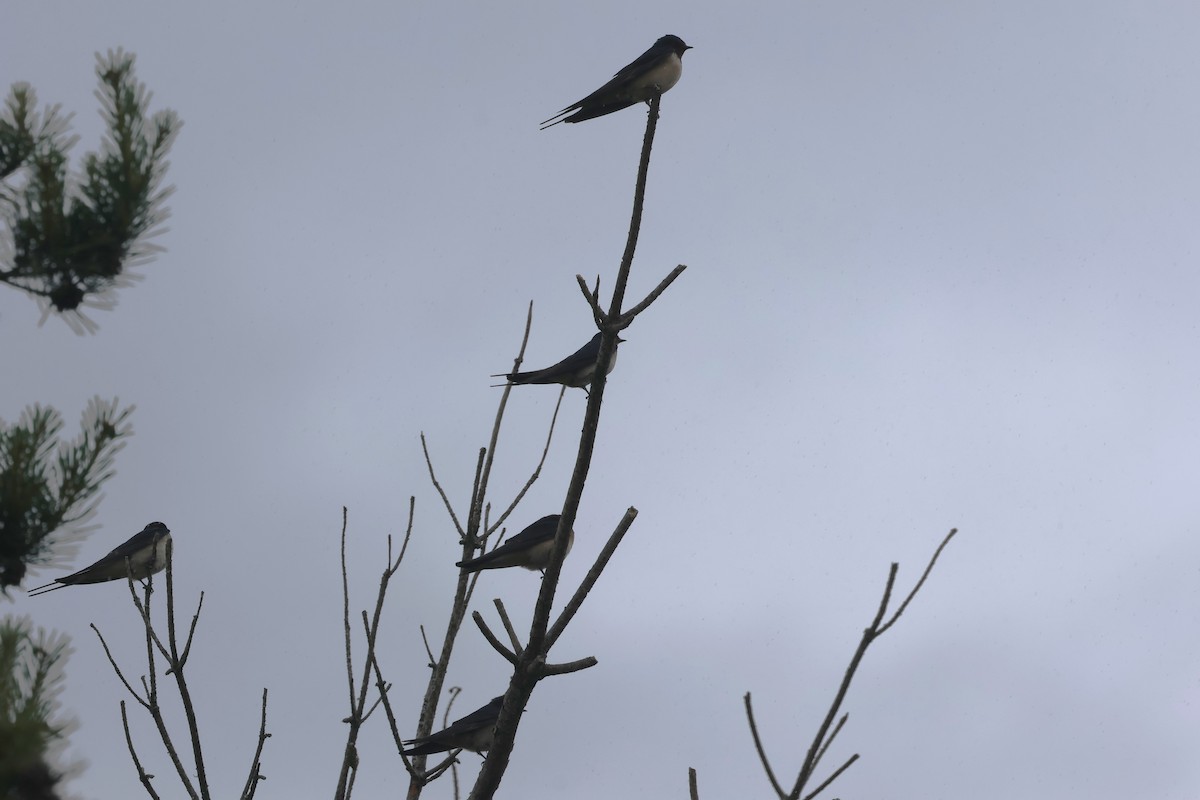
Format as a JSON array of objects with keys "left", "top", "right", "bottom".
[{"left": 0, "top": 0, "right": 1200, "bottom": 800}]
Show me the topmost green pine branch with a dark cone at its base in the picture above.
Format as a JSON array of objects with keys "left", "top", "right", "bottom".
[{"left": 0, "top": 49, "right": 181, "bottom": 332}]
